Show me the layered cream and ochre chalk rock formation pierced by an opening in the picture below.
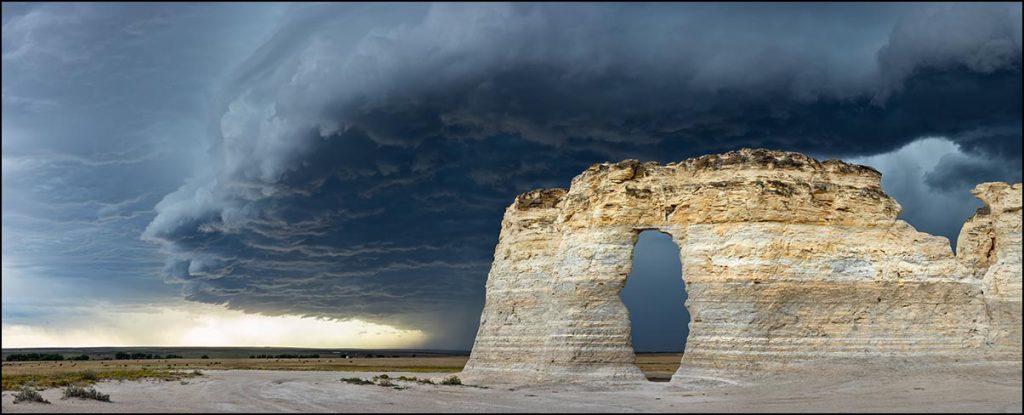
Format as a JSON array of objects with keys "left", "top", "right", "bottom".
[{"left": 462, "top": 149, "right": 1021, "bottom": 384}]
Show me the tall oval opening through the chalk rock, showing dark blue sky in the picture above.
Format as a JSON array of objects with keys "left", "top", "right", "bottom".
[{"left": 618, "top": 230, "right": 690, "bottom": 381}]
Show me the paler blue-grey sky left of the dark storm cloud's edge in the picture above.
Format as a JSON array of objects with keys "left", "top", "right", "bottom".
[{"left": 2, "top": 2, "right": 284, "bottom": 327}]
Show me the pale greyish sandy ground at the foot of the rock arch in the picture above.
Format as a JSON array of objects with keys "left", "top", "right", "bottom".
[{"left": 3, "top": 363, "right": 1021, "bottom": 413}]
